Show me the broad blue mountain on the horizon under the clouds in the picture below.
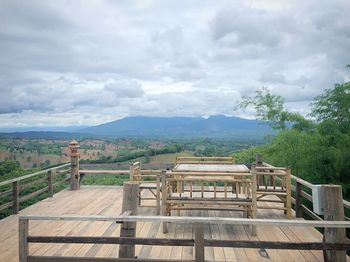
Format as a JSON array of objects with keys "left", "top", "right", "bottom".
[{"left": 80, "top": 115, "right": 273, "bottom": 138}]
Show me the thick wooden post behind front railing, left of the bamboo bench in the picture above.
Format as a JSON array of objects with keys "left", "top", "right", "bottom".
[{"left": 119, "top": 182, "right": 139, "bottom": 258}]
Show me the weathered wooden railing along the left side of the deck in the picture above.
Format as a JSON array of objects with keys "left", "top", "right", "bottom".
[{"left": 0, "top": 163, "right": 70, "bottom": 217}]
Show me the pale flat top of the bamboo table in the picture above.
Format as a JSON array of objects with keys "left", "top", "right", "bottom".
[{"left": 173, "top": 163, "right": 249, "bottom": 173}]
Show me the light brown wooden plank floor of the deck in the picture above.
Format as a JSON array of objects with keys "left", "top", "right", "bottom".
[{"left": 0, "top": 186, "right": 332, "bottom": 262}]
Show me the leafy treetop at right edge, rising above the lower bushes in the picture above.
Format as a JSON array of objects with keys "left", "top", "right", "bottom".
[{"left": 312, "top": 82, "right": 350, "bottom": 133}]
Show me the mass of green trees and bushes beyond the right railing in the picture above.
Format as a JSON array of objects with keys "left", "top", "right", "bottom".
[{"left": 235, "top": 77, "right": 350, "bottom": 198}]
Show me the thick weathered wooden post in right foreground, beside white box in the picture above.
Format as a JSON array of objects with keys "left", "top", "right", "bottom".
[{"left": 323, "top": 185, "right": 346, "bottom": 262}]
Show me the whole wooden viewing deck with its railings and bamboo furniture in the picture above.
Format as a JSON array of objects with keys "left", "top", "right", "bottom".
[{"left": 0, "top": 141, "right": 350, "bottom": 262}]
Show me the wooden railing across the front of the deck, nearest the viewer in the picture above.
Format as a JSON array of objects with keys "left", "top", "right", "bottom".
[{"left": 19, "top": 214, "right": 350, "bottom": 262}]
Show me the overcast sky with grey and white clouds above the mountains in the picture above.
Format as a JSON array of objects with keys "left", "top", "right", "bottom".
[{"left": 0, "top": 0, "right": 350, "bottom": 128}]
